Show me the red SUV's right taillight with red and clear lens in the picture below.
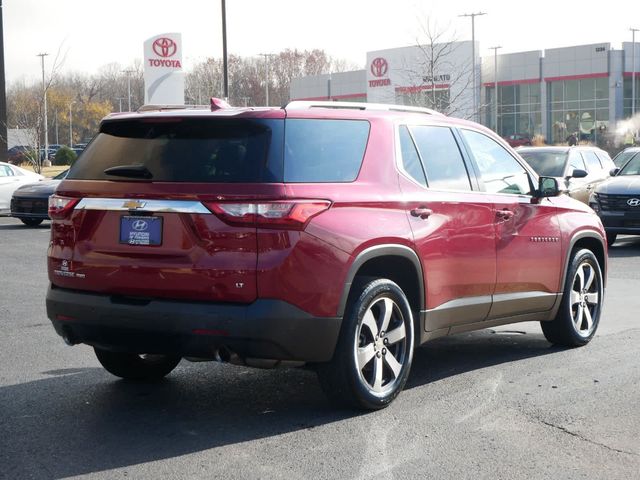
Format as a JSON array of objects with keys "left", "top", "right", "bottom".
[{"left": 204, "top": 200, "right": 331, "bottom": 230}]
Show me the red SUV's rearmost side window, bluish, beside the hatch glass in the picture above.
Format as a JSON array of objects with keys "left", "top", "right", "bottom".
[{"left": 284, "top": 119, "right": 369, "bottom": 182}]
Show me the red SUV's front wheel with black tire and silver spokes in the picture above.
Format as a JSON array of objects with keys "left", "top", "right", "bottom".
[{"left": 540, "top": 249, "right": 604, "bottom": 347}]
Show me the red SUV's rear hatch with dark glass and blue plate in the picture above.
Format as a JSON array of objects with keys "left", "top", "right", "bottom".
[{"left": 49, "top": 110, "right": 285, "bottom": 303}]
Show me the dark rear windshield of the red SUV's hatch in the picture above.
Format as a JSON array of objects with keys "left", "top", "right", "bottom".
[{"left": 67, "top": 118, "right": 283, "bottom": 183}]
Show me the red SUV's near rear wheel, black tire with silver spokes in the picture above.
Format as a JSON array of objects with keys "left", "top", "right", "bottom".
[{"left": 317, "top": 279, "right": 414, "bottom": 410}]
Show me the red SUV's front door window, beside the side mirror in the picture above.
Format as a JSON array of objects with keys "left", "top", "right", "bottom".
[{"left": 462, "top": 130, "right": 531, "bottom": 194}]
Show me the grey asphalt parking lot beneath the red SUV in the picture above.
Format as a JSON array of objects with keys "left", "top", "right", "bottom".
[{"left": 0, "top": 218, "right": 640, "bottom": 480}]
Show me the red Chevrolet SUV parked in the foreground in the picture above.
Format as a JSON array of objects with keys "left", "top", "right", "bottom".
[{"left": 47, "top": 102, "right": 607, "bottom": 409}]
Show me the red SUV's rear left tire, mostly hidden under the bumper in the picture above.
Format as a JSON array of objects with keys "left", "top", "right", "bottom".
[{"left": 94, "top": 348, "right": 181, "bottom": 380}]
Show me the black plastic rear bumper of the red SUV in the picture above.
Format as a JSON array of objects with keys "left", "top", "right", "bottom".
[{"left": 47, "top": 286, "right": 342, "bottom": 362}]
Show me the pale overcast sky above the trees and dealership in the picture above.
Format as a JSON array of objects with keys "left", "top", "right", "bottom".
[{"left": 5, "top": 0, "right": 640, "bottom": 82}]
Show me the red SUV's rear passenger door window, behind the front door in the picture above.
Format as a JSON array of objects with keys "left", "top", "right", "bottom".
[{"left": 411, "top": 126, "right": 471, "bottom": 190}]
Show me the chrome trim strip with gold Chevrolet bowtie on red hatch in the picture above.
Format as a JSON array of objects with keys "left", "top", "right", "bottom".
[{"left": 75, "top": 198, "right": 211, "bottom": 214}]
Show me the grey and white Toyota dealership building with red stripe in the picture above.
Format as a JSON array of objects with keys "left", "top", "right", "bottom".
[{"left": 290, "top": 41, "right": 640, "bottom": 143}]
